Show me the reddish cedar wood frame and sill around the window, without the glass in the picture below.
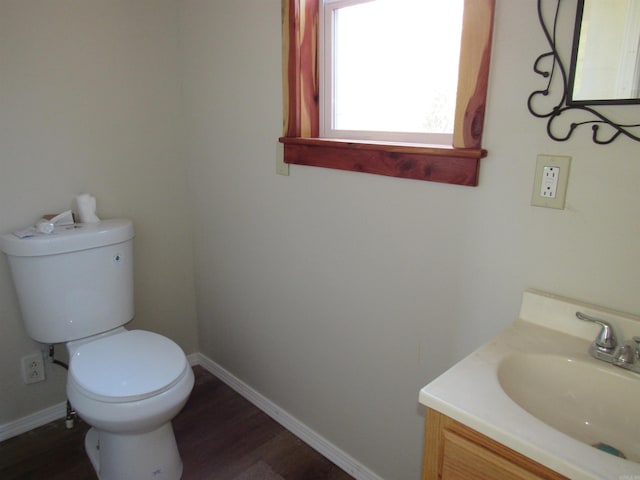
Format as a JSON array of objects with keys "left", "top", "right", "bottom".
[{"left": 280, "top": 0, "right": 495, "bottom": 185}]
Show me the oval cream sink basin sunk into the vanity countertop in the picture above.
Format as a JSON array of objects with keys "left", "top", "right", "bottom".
[{"left": 497, "top": 353, "right": 640, "bottom": 463}]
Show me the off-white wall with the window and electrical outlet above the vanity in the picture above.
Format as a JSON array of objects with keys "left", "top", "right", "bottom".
[{"left": 180, "top": 0, "right": 640, "bottom": 480}]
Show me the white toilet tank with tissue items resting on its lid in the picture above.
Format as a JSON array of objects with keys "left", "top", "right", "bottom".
[{"left": 0, "top": 219, "right": 134, "bottom": 344}]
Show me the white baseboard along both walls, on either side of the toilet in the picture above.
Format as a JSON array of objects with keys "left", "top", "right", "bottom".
[{"left": 0, "top": 353, "right": 383, "bottom": 480}]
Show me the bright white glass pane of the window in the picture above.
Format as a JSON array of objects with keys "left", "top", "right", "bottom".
[{"left": 333, "top": 0, "right": 463, "bottom": 133}]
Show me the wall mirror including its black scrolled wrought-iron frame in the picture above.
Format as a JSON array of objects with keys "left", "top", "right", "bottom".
[{"left": 527, "top": 0, "right": 640, "bottom": 145}]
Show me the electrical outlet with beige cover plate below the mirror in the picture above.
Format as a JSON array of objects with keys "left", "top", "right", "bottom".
[{"left": 531, "top": 155, "right": 571, "bottom": 210}]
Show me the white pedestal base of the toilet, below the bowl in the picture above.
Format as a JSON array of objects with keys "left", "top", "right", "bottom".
[{"left": 84, "top": 422, "right": 182, "bottom": 480}]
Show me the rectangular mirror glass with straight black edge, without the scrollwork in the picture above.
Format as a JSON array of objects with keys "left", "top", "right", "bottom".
[{"left": 569, "top": 0, "right": 640, "bottom": 105}]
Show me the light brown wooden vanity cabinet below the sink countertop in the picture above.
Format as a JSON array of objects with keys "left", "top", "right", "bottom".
[{"left": 422, "top": 408, "right": 568, "bottom": 480}]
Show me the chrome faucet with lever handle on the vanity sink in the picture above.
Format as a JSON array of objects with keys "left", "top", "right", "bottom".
[{"left": 576, "top": 312, "right": 640, "bottom": 373}]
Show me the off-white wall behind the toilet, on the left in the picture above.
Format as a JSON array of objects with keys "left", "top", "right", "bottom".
[{"left": 0, "top": 0, "right": 197, "bottom": 426}]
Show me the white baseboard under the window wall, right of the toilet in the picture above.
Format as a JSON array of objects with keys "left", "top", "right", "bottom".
[{"left": 194, "top": 353, "right": 383, "bottom": 480}]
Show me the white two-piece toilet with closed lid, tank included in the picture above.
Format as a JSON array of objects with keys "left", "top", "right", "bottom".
[{"left": 0, "top": 219, "right": 194, "bottom": 480}]
